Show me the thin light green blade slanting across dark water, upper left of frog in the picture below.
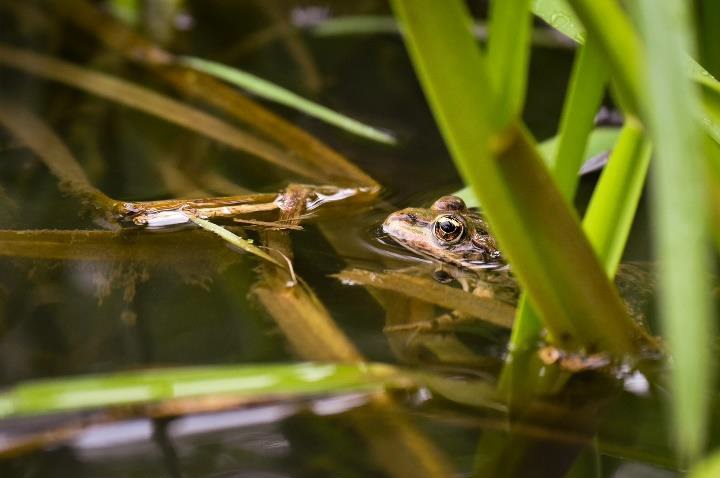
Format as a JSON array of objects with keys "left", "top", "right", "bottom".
[{"left": 178, "top": 56, "right": 396, "bottom": 144}]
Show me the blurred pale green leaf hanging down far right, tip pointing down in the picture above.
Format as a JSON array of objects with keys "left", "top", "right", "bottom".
[{"left": 635, "top": 0, "right": 713, "bottom": 460}]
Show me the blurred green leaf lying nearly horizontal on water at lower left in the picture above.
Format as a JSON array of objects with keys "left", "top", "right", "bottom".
[{"left": 0, "top": 363, "right": 395, "bottom": 418}]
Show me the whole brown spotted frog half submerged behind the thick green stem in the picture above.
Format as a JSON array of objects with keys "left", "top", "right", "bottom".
[{"left": 381, "top": 195, "right": 654, "bottom": 371}]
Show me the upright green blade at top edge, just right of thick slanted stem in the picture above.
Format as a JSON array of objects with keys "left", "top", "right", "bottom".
[{"left": 487, "top": 0, "right": 532, "bottom": 127}]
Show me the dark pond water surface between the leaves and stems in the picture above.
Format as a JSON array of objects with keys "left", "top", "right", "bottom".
[{"left": 0, "top": 1, "right": 708, "bottom": 477}]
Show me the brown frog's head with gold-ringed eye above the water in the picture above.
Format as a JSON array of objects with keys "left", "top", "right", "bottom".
[{"left": 382, "top": 196, "right": 505, "bottom": 269}]
